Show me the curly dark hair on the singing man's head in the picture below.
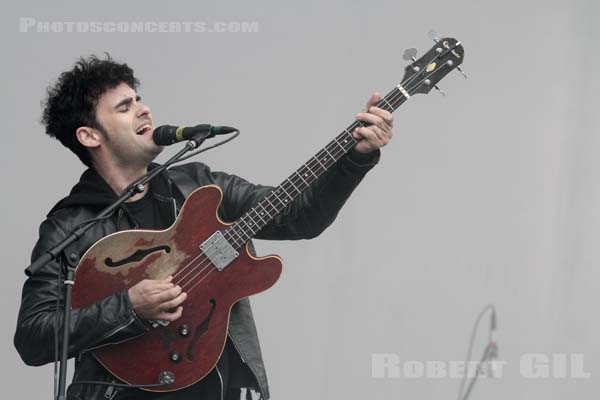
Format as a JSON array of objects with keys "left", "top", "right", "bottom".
[{"left": 42, "top": 53, "right": 139, "bottom": 167}]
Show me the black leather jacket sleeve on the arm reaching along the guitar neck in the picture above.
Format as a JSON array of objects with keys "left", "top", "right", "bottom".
[{"left": 183, "top": 150, "right": 380, "bottom": 240}]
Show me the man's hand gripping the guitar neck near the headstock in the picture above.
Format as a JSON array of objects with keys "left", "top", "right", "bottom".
[{"left": 353, "top": 93, "right": 394, "bottom": 154}]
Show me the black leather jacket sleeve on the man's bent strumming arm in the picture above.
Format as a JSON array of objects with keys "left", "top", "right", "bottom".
[{"left": 14, "top": 217, "right": 146, "bottom": 366}]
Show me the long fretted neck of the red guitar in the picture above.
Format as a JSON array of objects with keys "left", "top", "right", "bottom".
[{"left": 223, "top": 85, "right": 410, "bottom": 248}]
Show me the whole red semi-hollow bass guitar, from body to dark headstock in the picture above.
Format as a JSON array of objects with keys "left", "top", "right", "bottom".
[{"left": 72, "top": 38, "right": 464, "bottom": 392}]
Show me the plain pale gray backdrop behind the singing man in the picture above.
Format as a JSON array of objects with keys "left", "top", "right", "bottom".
[{"left": 0, "top": 0, "right": 600, "bottom": 399}]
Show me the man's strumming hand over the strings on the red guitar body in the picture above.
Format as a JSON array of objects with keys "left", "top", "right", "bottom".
[{"left": 128, "top": 276, "right": 187, "bottom": 322}]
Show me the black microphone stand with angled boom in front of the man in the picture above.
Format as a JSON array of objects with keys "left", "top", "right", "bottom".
[{"left": 27, "top": 131, "right": 210, "bottom": 400}]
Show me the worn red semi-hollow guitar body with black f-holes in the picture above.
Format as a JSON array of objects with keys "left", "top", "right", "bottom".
[{"left": 72, "top": 185, "right": 282, "bottom": 391}]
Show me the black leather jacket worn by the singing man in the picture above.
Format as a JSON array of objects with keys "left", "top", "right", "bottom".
[{"left": 14, "top": 152, "right": 379, "bottom": 400}]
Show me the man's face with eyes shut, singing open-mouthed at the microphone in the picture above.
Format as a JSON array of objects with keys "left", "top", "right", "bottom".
[{"left": 96, "top": 83, "right": 163, "bottom": 168}]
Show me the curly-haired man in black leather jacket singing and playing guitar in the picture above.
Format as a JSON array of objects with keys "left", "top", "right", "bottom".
[{"left": 14, "top": 56, "right": 393, "bottom": 399}]
